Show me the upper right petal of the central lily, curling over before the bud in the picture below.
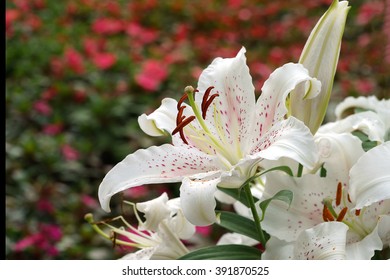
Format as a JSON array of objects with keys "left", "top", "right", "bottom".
[{"left": 254, "top": 63, "right": 321, "bottom": 137}]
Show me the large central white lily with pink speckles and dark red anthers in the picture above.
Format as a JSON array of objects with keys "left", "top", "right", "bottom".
[{"left": 99, "top": 48, "right": 321, "bottom": 225}]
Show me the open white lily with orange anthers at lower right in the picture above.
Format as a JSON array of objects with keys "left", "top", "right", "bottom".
[{"left": 262, "top": 140, "right": 390, "bottom": 259}]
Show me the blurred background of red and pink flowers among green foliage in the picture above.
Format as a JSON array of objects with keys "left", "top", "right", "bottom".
[{"left": 5, "top": 0, "right": 390, "bottom": 259}]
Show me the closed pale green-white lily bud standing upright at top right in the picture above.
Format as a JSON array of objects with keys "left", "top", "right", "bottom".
[{"left": 289, "top": 0, "right": 350, "bottom": 134}]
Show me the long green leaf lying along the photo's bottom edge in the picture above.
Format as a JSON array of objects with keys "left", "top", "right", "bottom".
[{"left": 179, "top": 244, "right": 261, "bottom": 260}]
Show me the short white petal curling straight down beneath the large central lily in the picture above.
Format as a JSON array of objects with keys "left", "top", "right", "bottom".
[{"left": 180, "top": 178, "right": 220, "bottom": 226}]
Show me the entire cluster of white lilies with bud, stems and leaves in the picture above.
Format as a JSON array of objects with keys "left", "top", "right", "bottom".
[{"left": 86, "top": 0, "right": 390, "bottom": 259}]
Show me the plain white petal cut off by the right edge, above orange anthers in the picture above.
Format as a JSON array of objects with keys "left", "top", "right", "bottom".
[{"left": 349, "top": 142, "right": 390, "bottom": 209}]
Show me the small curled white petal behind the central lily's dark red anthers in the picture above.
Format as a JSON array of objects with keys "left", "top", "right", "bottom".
[{"left": 138, "top": 98, "right": 177, "bottom": 136}]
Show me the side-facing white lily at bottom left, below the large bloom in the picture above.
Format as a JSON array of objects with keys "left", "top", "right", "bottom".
[{"left": 87, "top": 193, "right": 195, "bottom": 260}]
